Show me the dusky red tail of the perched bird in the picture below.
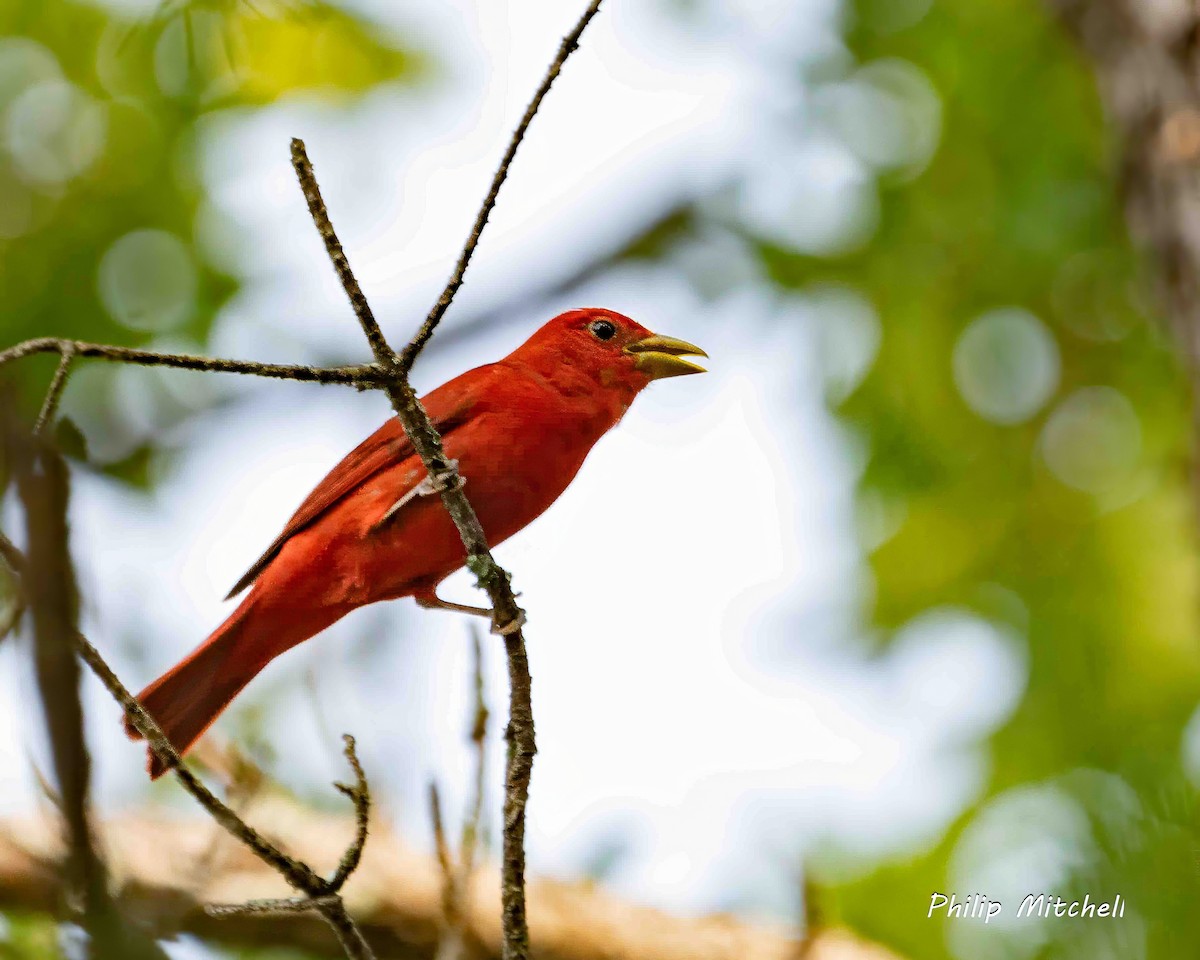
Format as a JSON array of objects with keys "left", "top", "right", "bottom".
[{"left": 125, "top": 594, "right": 268, "bottom": 780}]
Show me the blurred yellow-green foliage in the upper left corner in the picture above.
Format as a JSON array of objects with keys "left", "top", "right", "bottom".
[{"left": 0, "top": 0, "right": 422, "bottom": 482}]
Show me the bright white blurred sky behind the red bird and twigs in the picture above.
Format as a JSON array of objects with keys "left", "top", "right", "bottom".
[{"left": 0, "top": 0, "right": 1022, "bottom": 931}]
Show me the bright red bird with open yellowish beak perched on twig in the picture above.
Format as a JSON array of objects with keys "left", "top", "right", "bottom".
[{"left": 126, "top": 310, "right": 707, "bottom": 778}]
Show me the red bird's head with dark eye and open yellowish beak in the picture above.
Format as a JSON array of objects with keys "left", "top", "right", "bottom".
[{"left": 514, "top": 307, "right": 708, "bottom": 394}]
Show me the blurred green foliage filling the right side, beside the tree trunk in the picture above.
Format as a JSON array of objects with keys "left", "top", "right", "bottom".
[{"left": 739, "top": 0, "right": 1200, "bottom": 959}]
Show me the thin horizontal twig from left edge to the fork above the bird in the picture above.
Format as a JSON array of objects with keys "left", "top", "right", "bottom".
[{"left": 0, "top": 337, "right": 380, "bottom": 390}]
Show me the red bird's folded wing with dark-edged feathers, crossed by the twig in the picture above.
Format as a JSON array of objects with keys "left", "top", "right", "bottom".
[{"left": 226, "top": 370, "right": 482, "bottom": 600}]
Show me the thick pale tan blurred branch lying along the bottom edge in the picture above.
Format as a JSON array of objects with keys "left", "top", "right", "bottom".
[{"left": 0, "top": 797, "right": 896, "bottom": 960}]
